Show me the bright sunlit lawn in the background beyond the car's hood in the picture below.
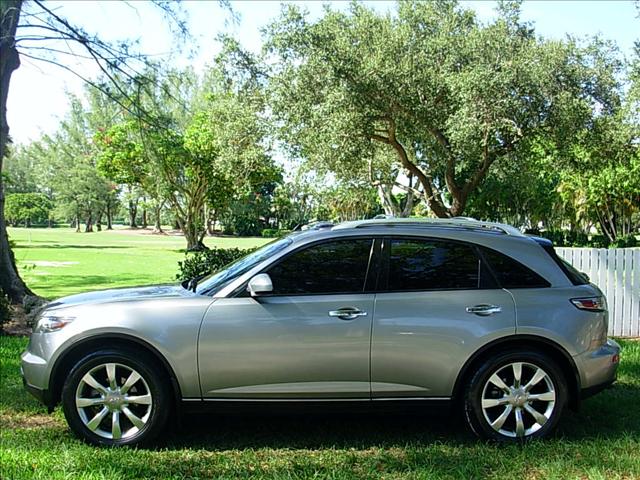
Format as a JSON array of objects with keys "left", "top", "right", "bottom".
[{"left": 9, "top": 228, "right": 268, "bottom": 299}]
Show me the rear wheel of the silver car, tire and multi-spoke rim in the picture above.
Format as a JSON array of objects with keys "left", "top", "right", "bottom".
[{"left": 464, "top": 350, "right": 567, "bottom": 442}]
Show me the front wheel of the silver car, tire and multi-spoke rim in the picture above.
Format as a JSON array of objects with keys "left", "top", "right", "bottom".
[{"left": 62, "top": 348, "right": 172, "bottom": 446}]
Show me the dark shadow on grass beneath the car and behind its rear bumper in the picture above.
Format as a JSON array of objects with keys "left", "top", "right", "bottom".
[{"left": 158, "top": 384, "right": 640, "bottom": 451}]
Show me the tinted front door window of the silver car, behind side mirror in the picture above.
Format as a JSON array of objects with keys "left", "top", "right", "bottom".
[{"left": 268, "top": 239, "right": 372, "bottom": 295}]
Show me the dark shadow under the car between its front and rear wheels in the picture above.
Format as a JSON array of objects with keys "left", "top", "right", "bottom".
[{"left": 158, "top": 412, "right": 475, "bottom": 451}]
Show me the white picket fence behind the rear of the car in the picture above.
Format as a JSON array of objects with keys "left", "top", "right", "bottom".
[{"left": 556, "top": 247, "right": 640, "bottom": 337}]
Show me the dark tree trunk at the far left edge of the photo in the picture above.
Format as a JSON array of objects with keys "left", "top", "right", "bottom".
[{"left": 0, "top": 0, "right": 33, "bottom": 303}]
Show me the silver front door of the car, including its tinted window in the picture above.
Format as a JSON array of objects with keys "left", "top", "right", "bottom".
[{"left": 198, "top": 238, "right": 374, "bottom": 399}]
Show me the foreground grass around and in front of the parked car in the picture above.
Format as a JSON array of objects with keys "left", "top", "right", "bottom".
[{"left": 0, "top": 337, "right": 640, "bottom": 480}]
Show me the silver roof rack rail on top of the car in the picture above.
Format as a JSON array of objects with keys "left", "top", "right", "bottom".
[{"left": 333, "top": 217, "right": 524, "bottom": 237}]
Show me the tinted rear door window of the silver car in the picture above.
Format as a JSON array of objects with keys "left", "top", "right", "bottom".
[{"left": 388, "top": 239, "right": 480, "bottom": 291}]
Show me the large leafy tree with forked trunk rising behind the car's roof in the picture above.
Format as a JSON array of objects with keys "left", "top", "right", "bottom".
[{"left": 262, "top": 2, "right": 606, "bottom": 217}]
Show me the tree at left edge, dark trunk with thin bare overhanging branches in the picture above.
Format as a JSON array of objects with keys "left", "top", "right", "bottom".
[{"left": 0, "top": 0, "right": 192, "bottom": 302}]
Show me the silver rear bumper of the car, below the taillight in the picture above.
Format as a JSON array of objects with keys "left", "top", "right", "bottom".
[{"left": 574, "top": 339, "right": 620, "bottom": 398}]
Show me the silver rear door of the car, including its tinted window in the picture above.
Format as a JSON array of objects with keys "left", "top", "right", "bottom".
[{"left": 371, "top": 237, "right": 516, "bottom": 399}]
